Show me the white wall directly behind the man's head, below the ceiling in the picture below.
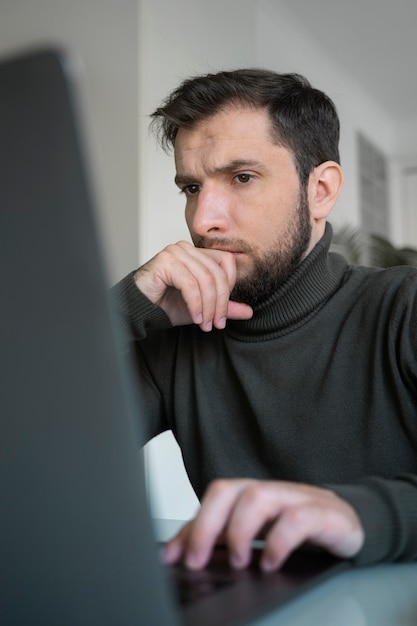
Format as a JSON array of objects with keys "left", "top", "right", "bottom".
[{"left": 139, "top": 0, "right": 417, "bottom": 519}]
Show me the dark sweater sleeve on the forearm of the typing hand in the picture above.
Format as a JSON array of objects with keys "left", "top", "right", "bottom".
[{"left": 329, "top": 474, "right": 417, "bottom": 565}]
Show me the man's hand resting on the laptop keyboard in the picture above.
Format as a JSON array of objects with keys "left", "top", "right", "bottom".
[{"left": 164, "top": 479, "right": 364, "bottom": 571}]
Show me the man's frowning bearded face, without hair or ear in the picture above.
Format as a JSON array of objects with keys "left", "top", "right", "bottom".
[{"left": 175, "top": 106, "right": 312, "bottom": 306}]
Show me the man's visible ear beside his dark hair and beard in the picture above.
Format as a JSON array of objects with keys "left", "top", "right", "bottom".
[{"left": 308, "top": 161, "right": 343, "bottom": 220}]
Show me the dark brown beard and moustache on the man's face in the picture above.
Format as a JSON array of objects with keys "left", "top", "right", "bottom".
[{"left": 197, "top": 190, "right": 312, "bottom": 307}]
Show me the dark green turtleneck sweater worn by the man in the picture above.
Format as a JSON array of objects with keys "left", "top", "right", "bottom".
[{"left": 113, "top": 225, "right": 417, "bottom": 564}]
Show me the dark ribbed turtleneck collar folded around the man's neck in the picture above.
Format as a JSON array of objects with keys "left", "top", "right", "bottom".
[{"left": 226, "top": 223, "right": 348, "bottom": 342}]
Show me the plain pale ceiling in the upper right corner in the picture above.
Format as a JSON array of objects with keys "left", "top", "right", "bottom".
[{"left": 281, "top": 0, "right": 417, "bottom": 120}]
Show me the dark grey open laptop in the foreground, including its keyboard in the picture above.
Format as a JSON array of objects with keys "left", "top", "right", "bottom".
[{"left": 0, "top": 49, "right": 348, "bottom": 626}]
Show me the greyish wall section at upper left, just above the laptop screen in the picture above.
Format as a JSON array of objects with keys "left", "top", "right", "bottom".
[{"left": 0, "top": 0, "right": 138, "bottom": 282}]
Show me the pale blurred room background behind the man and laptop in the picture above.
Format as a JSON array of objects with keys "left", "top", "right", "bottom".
[{"left": 0, "top": 0, "right": 417, "bottom": 519}]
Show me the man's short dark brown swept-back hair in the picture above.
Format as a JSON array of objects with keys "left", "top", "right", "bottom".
[{"left": 151, "top": 69, "right": 340, "bottom": 185}]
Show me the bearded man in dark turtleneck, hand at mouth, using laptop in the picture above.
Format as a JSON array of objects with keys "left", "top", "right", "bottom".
[{"left": 114, "top": 70, "right": 417, "bottom": 571}]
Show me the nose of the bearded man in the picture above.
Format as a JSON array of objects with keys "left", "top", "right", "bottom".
[{"left": 187, "top": 188, "right": 229, "bottom": 237}]
